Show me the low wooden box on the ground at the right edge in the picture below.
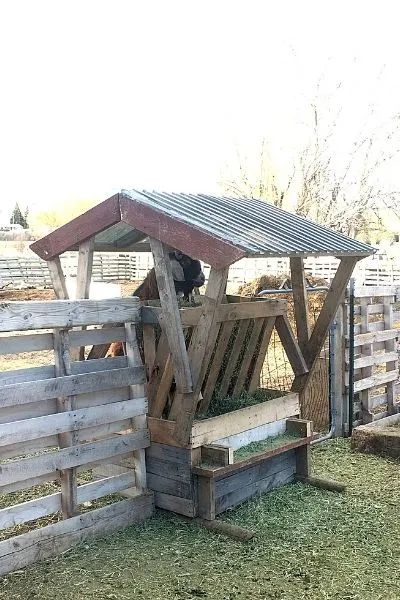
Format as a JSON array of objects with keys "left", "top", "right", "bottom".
[{"left": 351, "top": 413, "right": 400, "bottom": 458}]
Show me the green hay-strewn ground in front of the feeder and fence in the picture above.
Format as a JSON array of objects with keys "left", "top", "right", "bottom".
[{"left": 0, "top": 440, "right": 400, "bottom": 600}]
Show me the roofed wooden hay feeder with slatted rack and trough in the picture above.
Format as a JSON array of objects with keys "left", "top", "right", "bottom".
[{"left": 32, "top": 190, "right": 373, "bottom": 519}]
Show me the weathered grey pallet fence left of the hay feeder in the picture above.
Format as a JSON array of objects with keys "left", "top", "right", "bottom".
[{"left": 0, "top": 298, "right": 153, "bottom": 575}]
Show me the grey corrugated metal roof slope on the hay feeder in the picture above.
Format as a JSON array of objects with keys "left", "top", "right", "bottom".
[{"left": 121, "top": 190, "right": 375, "bottom": 256}]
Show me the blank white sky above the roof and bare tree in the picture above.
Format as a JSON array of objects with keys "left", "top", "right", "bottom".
[{"left": 0, "top": 0, "right": 400, "bottom": 219}]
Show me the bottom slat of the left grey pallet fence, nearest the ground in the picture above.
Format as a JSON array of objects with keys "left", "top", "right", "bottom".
[{"left": 0, "top": 494, "right": 153, "bottom": 575}]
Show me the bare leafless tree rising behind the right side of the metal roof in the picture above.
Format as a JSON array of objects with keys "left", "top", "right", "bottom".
[{"left": 220, "top": 75, "right": 400, "bottom": 238}]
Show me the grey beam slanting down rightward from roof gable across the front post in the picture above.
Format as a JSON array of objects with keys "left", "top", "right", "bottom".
[{"left": 150, "top": 238, "right": 192, "bottom": 394}]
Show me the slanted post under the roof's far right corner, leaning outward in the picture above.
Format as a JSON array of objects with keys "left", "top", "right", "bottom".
[{"left": 292, "top": 256, "right": 360, "bottom": 392}]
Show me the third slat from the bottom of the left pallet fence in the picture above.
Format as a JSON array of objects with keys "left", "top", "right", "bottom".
[{"left": 0, "top": 430, "right": 149, "bottom": 488}]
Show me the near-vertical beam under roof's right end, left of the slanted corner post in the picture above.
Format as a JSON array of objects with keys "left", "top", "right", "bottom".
[{"left": 290, "top": 257, "right": 310, "bottom": 351}]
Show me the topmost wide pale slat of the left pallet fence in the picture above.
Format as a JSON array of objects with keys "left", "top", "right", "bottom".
[{"left": 0, "top": 296, "right": 140, "bottom": 331}]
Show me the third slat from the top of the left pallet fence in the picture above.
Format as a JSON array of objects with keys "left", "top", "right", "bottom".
[{"left": 0, "top": 367, "right": 145, "bottom": 408}]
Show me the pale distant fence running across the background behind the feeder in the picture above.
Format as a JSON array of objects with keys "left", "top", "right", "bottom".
[{"left": 0, "top": 252, "right": 400, "bottom": 288}]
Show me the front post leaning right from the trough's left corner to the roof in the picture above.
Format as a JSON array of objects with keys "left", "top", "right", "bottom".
[{"left": 175, "top": 267, "right": 229, "bottom": 443}]
